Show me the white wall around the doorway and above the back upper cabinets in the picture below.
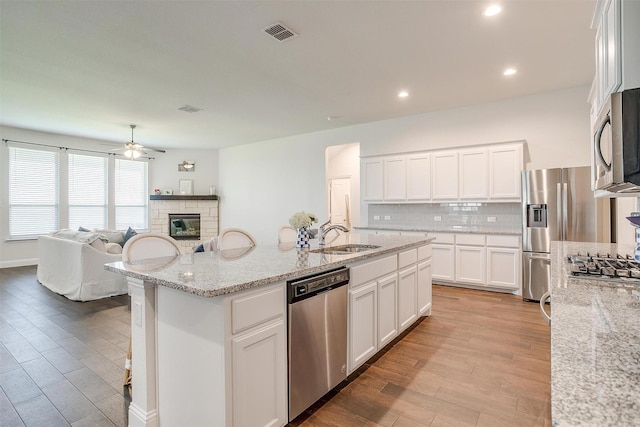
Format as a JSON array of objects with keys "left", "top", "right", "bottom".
[{"left": 219, "top": 86, "right": 591, "bottom": 243}]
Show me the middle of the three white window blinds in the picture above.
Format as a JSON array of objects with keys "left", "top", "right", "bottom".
[{"left": 68, "top": 153, "right": 107, "bottom": 230}]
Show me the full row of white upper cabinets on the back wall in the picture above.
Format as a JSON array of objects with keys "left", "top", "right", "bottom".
[{"left": 361, "top": 142, "right": 524, "bottom": 203}]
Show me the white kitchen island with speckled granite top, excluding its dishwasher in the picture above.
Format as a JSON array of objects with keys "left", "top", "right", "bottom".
[{"left": 105, "top": 233, "right": 432, "bottom": 427}]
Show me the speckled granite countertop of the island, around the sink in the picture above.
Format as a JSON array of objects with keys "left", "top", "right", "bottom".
[{"left": 105, "top": 233, "right": 433, "bottom": 297}]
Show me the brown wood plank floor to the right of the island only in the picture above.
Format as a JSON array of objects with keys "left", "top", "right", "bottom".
[{"left": 290, "top": 286, "right": 551, "bottom": 427}]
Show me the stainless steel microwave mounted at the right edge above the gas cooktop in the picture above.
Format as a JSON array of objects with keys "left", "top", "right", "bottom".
[{"left": 592, "top": 88, "right": 640, "bottom": 196}]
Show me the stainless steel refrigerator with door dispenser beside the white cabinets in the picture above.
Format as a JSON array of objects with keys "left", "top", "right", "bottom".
[{"left": 522, "top": 166, "right": 615, "bottom": 301}]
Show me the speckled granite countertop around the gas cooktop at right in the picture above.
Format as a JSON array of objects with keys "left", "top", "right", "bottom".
[{"left": 551, "top": 242, "right": 640, "bottom": 427}]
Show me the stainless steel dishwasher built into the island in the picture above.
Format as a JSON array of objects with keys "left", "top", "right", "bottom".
[{"left": 287, "top": 267, "right": 349, "bottom": 421}]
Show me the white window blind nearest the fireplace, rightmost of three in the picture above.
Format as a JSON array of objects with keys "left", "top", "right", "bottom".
[{"left": 115, "top": 159, "right": 149, "bottom": 230}]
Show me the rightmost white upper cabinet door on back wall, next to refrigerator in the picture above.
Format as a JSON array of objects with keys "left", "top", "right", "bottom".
[{"left": 488, "top": 144, "right": 524, "bottom": 202}]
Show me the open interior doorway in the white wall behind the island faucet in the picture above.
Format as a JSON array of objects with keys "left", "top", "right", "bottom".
[{"left": 325, "top": 142, "right": 360, "bottom": 229}]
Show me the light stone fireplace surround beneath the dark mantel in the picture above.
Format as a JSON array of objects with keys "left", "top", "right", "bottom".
[{"left": 149, "top": 196, "right": 218, "bottom": 253}]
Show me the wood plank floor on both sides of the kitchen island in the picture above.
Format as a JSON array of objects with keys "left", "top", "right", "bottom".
[{"left": 0, "top": 267, "right": 551, "bottom": 427}]
